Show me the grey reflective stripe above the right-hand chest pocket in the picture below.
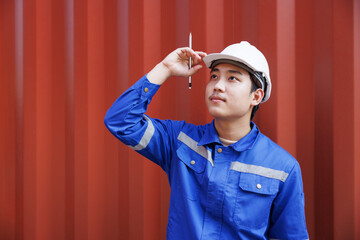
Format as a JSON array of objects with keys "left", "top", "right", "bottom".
[{"left": 230, "top": 162, "right": 289, "bottom": 182}]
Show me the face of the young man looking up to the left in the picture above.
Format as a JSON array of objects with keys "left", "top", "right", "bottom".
[{"left": 205, "top": 63, "right": 255, "bottom": 120}]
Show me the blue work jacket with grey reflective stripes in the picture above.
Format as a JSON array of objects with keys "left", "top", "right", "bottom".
[{"left": 105, "top": 76, "right": 309, "bottom": 240}]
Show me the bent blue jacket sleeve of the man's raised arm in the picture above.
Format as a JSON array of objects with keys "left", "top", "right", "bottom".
[{"left": 104, "top": 76, "right": 183, "bottom": 173}]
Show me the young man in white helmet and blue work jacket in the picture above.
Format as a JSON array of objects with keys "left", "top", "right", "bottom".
[{"left": 105, "top": 42, "right": 309, "bottom": 240}]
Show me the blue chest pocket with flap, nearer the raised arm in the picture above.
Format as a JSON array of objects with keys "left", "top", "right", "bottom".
[{"left": 176, "top": 144, "right": 207, "bottom": 200}]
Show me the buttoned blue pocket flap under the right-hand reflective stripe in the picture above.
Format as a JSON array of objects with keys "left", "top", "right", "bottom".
[{"left": 239, "top": 173, "right": 280, "bottom": 195}]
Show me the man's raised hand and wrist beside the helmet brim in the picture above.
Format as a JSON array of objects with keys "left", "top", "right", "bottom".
[{"left": 147, "top": 47, "right": 206, "bottom": 85}]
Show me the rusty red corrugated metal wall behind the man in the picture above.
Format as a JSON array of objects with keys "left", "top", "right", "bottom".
[{"left": 0, "top": 0, "right": 360, "bottom": 240}]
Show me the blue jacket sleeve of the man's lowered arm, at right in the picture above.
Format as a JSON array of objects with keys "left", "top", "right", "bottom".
[{"left": 269, "top": 162, "right": 309, "bottom": 240}]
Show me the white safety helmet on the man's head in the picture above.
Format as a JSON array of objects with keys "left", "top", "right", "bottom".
[{"left": 204, "top": 41, "right": 271, "bottom": 103}]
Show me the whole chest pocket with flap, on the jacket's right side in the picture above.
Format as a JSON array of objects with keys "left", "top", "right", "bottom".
[{"left": 234, "top": 173, "right": 281, "bottom": 229}]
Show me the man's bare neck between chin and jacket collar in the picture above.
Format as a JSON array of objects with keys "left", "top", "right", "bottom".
[{"left": 214, "top": 119, "right": 251, "bottom": 141}]
